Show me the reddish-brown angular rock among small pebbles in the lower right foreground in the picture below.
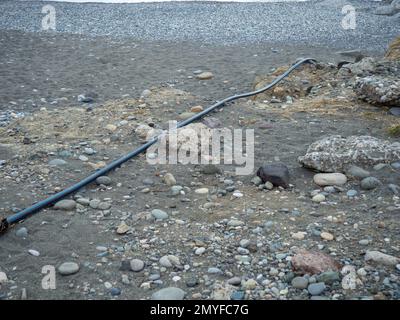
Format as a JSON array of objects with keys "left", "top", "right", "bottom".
[{"left": 292, "top": 250, "right": 341, "bottom": 274}]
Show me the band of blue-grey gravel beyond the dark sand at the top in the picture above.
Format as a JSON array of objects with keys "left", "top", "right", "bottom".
[{"left": 0, "top": 1, "right": 398, "bottom": 50}]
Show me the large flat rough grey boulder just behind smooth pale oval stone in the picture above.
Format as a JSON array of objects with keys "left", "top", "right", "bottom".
[{"left": 298, "top": 135, "right": 400, "bottom": 172}]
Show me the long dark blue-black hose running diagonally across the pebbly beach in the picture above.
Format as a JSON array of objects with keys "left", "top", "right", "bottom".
[{"left": 0, "top": 58, "right": 315, "bottom": 233}]
